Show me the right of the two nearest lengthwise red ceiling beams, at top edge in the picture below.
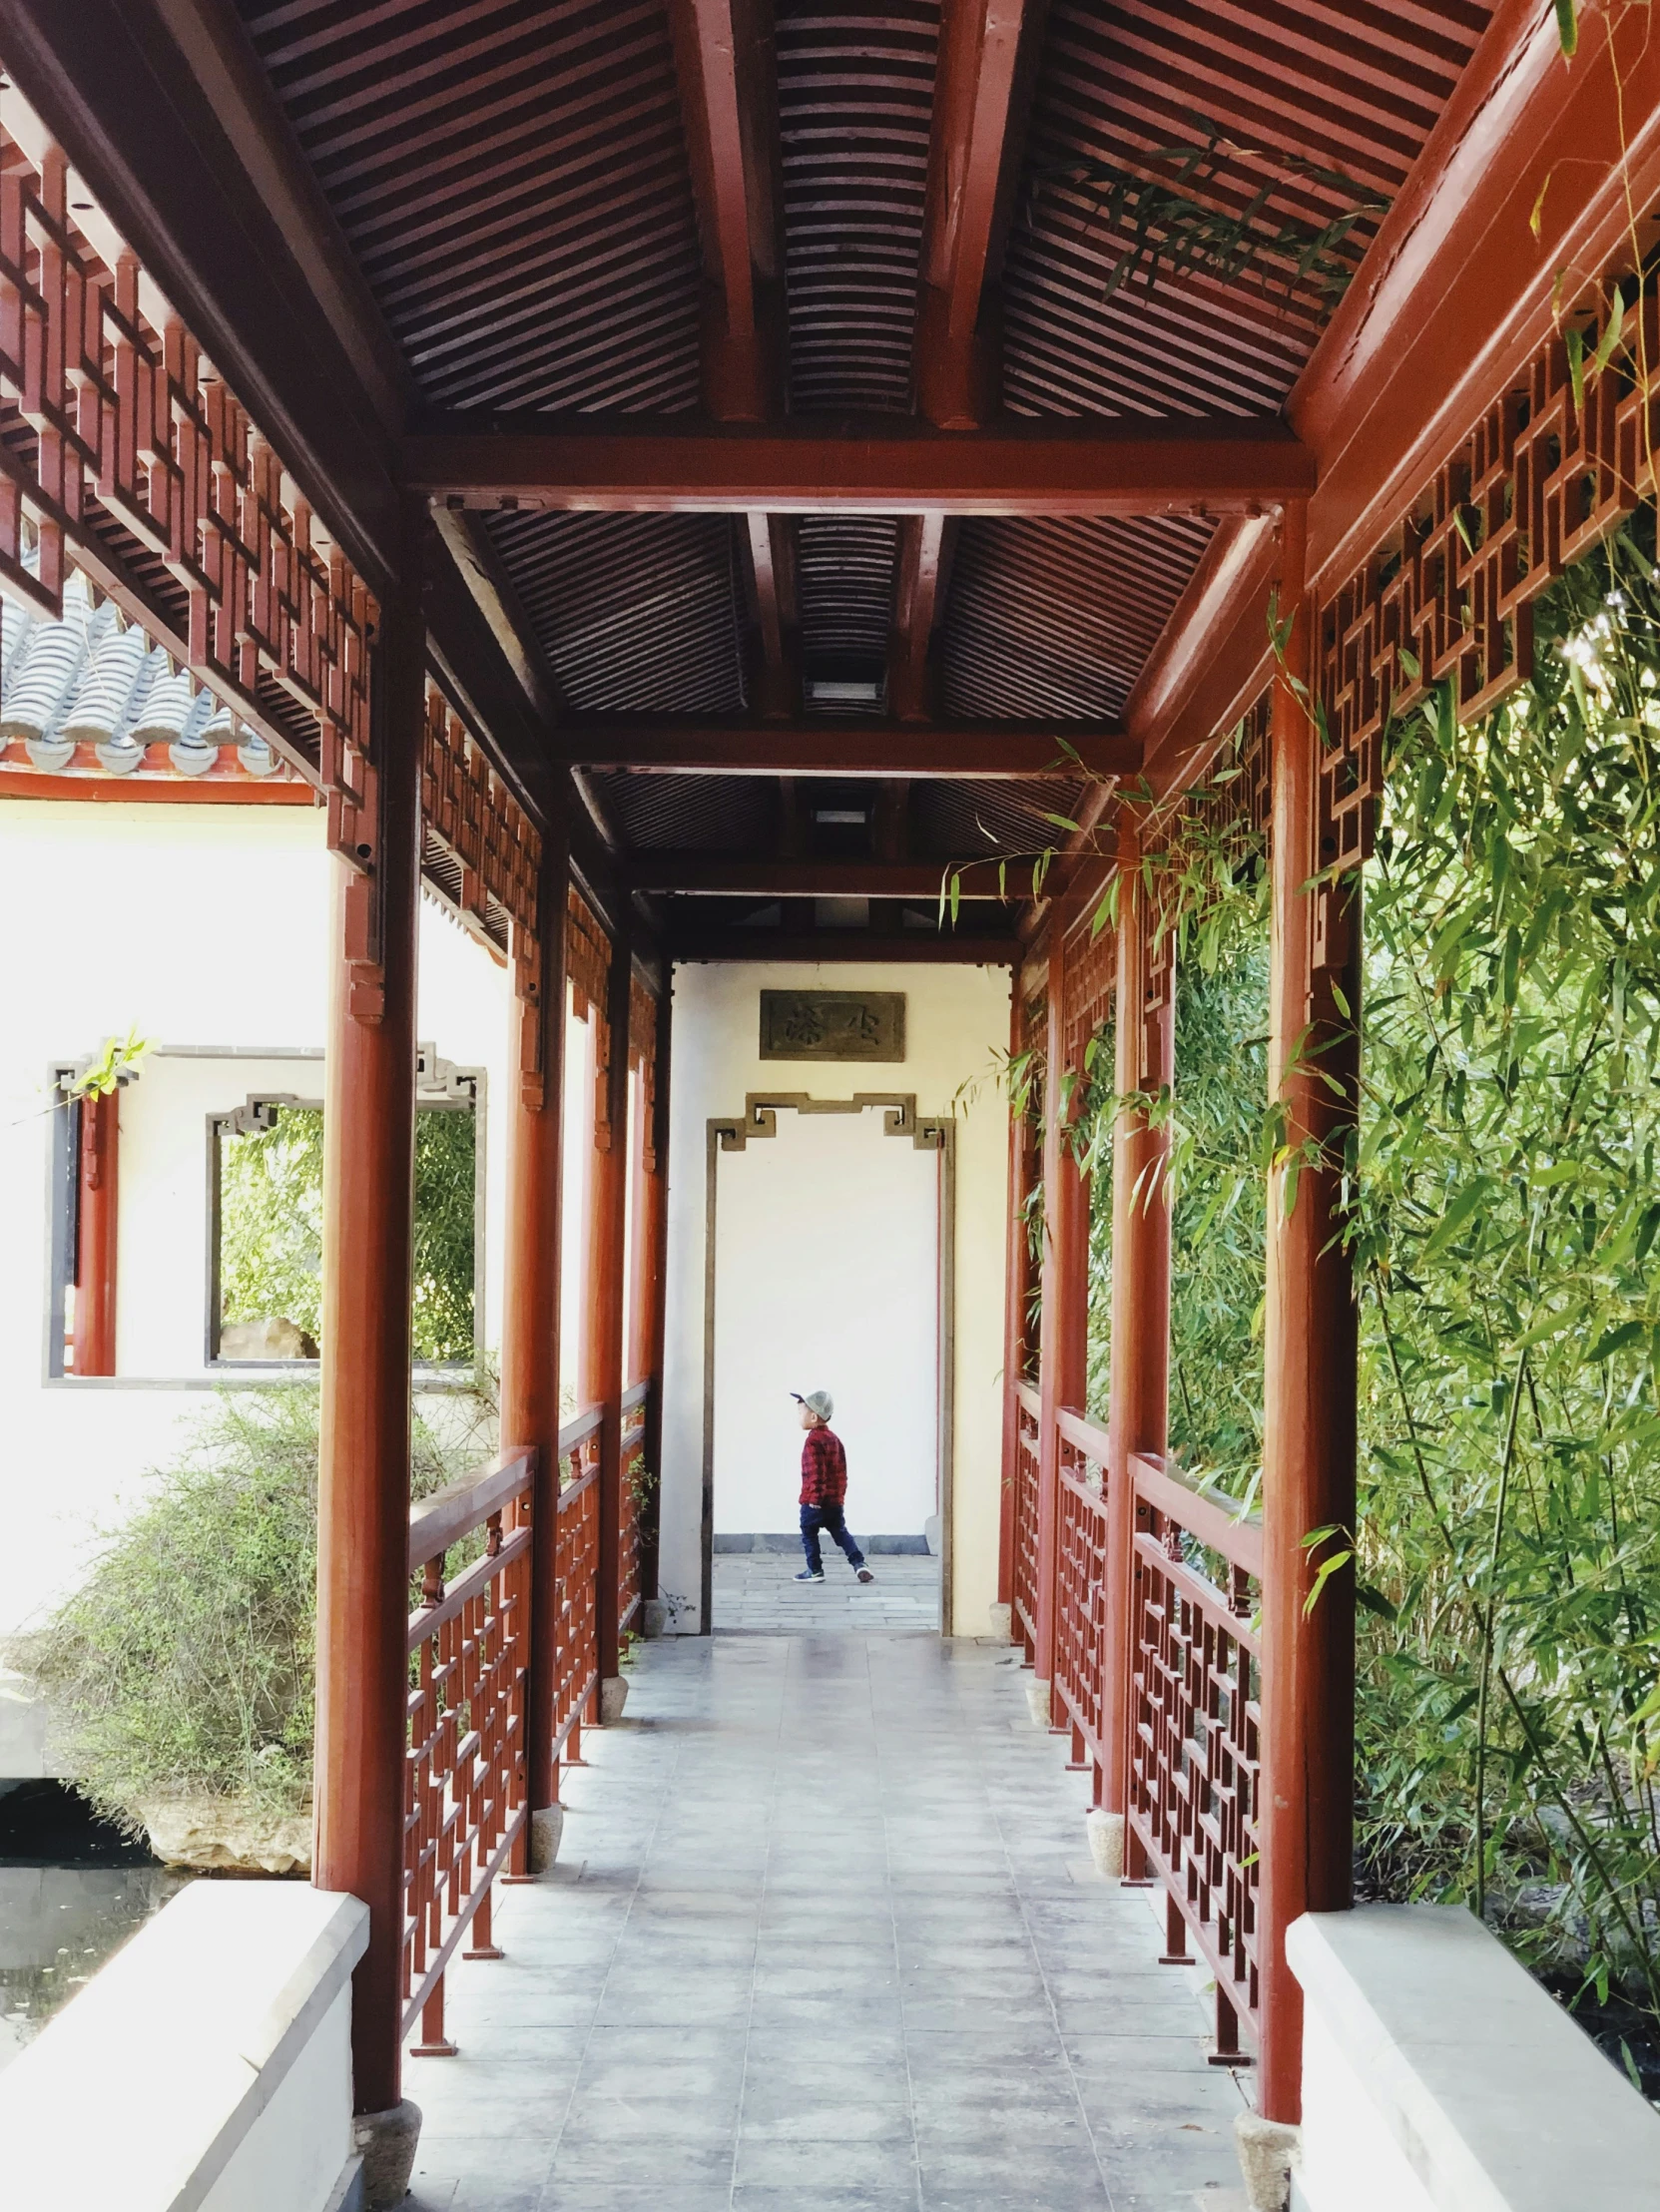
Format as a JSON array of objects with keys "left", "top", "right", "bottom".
[{"left": 916, "top": 0, "right": 1047, "bottom": 429}]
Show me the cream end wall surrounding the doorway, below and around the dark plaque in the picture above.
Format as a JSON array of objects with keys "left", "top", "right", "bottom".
[{"left": 662, "top": 962, "right": 1009, "bottom": 1635}]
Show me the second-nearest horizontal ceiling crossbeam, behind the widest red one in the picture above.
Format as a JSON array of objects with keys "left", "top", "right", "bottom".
[{"left": 551, "top": 715, "right": 1142, "bottom": 781}]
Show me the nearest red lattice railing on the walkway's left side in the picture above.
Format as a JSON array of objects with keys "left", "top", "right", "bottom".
[{"left": 403, "top": 1451, "right": 536, "bottom": 2055}]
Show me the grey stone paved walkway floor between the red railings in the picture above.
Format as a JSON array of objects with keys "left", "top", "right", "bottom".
[{"left": 407, "top": 1635, "right": 1244, "bottom": 2212}]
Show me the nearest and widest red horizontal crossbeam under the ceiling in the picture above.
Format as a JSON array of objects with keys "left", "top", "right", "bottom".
[{"left": 413, "top": 416, "right": 1315, "bottom": 515}]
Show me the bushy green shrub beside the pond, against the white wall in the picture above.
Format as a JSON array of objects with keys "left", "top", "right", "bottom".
[{"left": 29, "top": 1384, "right": 487, "bottom": 1827}]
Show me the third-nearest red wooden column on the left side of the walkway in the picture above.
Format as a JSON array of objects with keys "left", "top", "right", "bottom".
[{"left": 578, "top": 897, "right": 629, "bottom": 1690}]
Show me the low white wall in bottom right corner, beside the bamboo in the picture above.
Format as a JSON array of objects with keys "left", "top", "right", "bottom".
[{"left": 1286, "top": 1905, "right": 1660, "bottom": 2212}]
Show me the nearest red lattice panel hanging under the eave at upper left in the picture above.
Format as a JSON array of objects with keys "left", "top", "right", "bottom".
[{"left": 0, "top": 133, "right": 378, "bottom": 844}]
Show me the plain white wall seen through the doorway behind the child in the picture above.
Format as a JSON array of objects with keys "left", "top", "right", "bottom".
[{"left": 715, "top": 1108, "right": 940, "bottom": 1535}]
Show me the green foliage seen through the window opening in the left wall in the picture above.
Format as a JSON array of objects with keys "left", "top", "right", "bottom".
[{"left": 220, "top": 1106, "right": 478, "bottom": 1365}]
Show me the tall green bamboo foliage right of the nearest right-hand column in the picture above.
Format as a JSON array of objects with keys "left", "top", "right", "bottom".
[{"left": 1355, "top": 530, "right": 1660, "bottom": 2004}]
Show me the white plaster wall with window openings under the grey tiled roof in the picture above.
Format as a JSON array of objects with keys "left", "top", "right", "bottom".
[{"left": 0, "top": 799, "right": 511, "bottom": 1635}]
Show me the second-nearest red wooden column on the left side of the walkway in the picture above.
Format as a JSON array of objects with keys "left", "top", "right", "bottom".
[{"left": 502, "top": 826, "right": 571, "bottom": 1863}]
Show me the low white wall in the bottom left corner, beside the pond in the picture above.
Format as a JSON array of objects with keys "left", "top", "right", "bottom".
[{"left": 0, "top": 1883, "right": 369, "bottom": 2212}]
